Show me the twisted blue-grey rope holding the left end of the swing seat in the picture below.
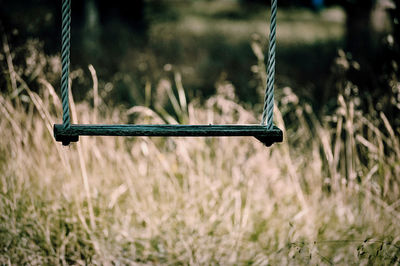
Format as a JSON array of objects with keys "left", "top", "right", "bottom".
[{"left": 61, "top": 0, "right": 71, "bottom": 128}]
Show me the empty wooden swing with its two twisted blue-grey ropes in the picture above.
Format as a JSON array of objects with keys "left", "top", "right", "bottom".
[{"left": 54, "top": 0, "right": 283, "bottom": 146}]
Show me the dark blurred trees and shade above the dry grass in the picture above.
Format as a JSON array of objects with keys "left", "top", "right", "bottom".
[{"left": 0, "top": 0, "right": 399, "bottom": 123}]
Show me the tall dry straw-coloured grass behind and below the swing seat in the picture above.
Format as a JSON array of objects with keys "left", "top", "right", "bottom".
[{"left": 0, "top": 40, "right": 400, "bottom": 265}]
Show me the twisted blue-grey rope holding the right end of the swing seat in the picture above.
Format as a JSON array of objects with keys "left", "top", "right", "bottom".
[{"left": 261, "top": 0, "right": 278, "bottom": 130}]
